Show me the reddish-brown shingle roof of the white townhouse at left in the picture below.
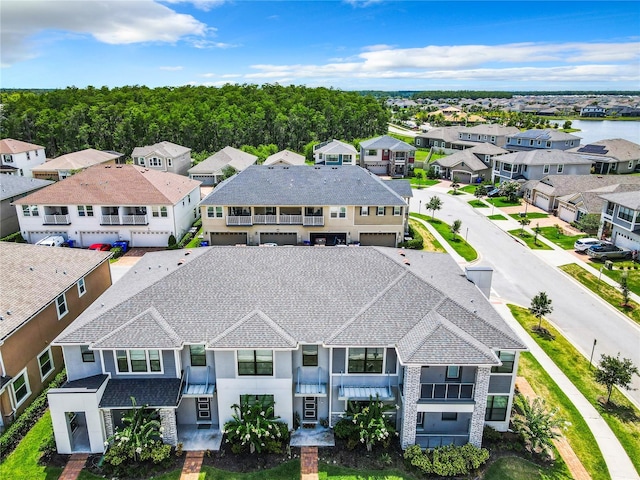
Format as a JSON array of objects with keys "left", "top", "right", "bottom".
[{"left": 14, "top": 164, "right": 200, "bottom": 206}]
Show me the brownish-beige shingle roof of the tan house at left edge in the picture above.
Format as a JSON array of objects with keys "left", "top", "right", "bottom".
[{"left": 0, "top": 242, "right": 111, "bottom": 340}]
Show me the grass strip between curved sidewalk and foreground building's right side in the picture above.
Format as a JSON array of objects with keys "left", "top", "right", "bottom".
[{"left": 512, "top": 350, "right": 610, "bottom": 479}]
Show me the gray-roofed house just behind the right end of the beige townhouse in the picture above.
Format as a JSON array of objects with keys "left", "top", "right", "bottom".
[{"left": 360, "top": 135, "right": 416, "bottom": 177}]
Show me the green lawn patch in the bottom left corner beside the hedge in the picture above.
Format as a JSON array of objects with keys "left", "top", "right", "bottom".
[{"left": 0, "top": 410, "right": 62, "bottom": 480}]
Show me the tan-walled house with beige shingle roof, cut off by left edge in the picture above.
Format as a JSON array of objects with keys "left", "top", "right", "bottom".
[{"left": 0, "top": 242, "right": 111, "bottom": 431}]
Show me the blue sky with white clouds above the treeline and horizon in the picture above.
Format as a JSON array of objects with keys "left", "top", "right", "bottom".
[{"left": 0, "top": 0, "right": 640, "bottom": 90}]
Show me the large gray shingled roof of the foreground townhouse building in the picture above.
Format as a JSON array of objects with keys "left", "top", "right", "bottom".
[{"left": 56, "top": 247, "right": 525, "bottom": 365}]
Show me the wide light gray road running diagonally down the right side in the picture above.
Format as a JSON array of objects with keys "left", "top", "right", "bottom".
[{"left": 411, "top": 187, "right": 640, "bottom": 404}]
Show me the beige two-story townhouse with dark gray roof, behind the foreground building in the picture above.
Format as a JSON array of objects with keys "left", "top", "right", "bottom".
[{"left": 200, "top": 165, "right": 411, "bottom": 247}]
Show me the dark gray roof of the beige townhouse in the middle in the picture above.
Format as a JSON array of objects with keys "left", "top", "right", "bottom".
[{"left": 200, "top": 165, "right": 406, "bottom": 206}]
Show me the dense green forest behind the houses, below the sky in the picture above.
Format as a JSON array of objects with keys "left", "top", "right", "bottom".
[{"left": 0, "top": 84, "right": 389, "bottom": 157}]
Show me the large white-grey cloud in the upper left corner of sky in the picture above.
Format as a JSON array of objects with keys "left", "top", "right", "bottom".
[{"left": 0, "top": 0, "right": 208, "bottom": 65}]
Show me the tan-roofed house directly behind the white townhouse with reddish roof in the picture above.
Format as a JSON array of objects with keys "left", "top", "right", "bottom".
[{"left": 31, "top": 148, "right": 124, "bottom": 180}]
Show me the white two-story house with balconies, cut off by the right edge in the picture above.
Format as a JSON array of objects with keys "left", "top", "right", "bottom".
[{"left": 598, "top": 188, "right": 640, "bottom": 252}]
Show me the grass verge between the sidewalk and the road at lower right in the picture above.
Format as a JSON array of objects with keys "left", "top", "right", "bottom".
[{"left": 509, "top": 305, "right": 640, "bottom": 478}]
